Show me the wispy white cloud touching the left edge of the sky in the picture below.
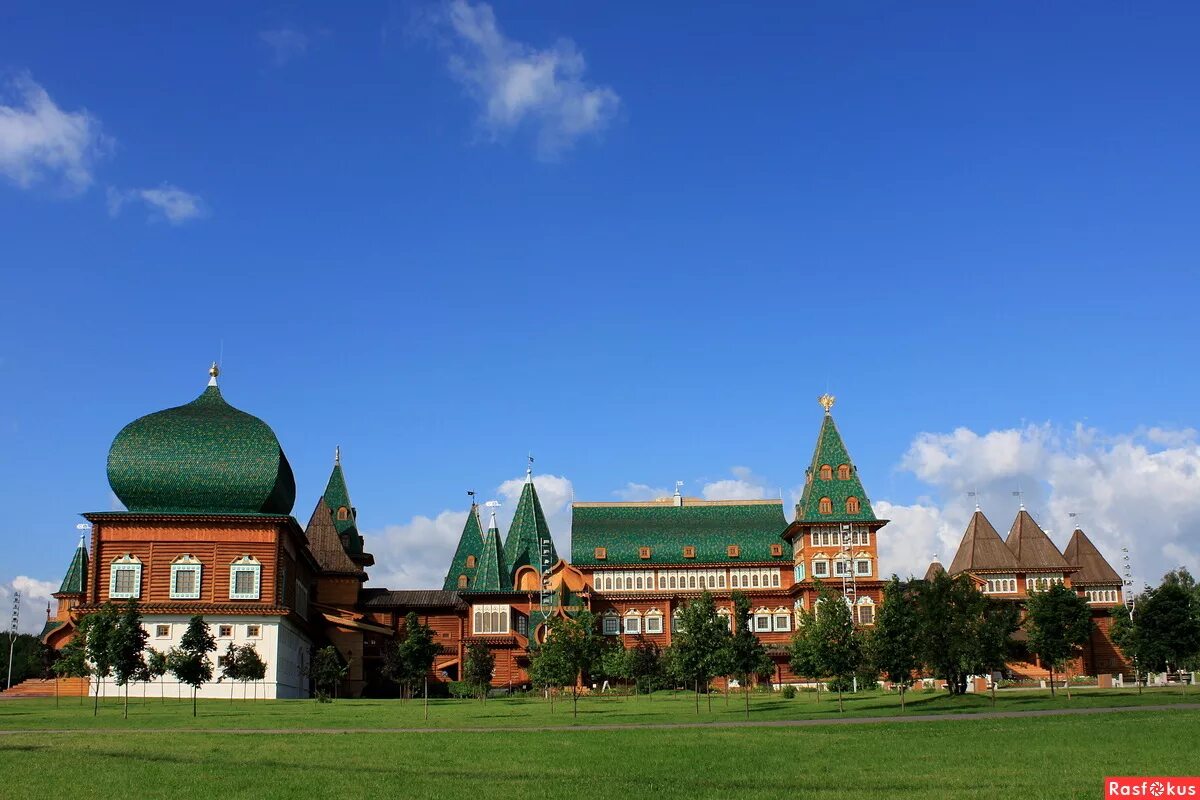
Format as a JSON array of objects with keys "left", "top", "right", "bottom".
[{"left": 0, "top": 74, "right": 110, "bottom": 193}]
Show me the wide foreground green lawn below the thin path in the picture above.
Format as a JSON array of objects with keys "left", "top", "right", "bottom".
[{"left": 0, "top": 703, "right": 1200, "bottom": 800}]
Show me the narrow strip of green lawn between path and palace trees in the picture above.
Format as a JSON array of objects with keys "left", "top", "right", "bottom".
[{"left": 0, "top": 688, "right": 1200, "bottom": 730}]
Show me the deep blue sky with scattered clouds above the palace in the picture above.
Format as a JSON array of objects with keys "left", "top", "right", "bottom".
[{"left": 0, "top": 0, "right": 1200, "bottom": 623}]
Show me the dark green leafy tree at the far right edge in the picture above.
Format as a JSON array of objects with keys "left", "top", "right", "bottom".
[{"left": 1133, "top": 573, "right": 1200, "bottom": 693}]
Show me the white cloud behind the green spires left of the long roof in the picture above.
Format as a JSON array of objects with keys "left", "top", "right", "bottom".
[{"left": 364, "top": 475, "right": 575, "bottom": 589}]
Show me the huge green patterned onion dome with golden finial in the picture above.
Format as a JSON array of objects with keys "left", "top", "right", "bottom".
[{"left": 108, "top": 365, "right": 296, "bottom": 515}]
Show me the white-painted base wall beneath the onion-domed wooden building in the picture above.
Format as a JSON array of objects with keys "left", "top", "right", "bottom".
[{"left": 91, "top": 614, "right": 312, "bottom": 699}]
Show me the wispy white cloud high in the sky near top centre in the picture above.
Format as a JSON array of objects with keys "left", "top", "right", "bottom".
[{"left": 445, "top": 0, "right": 620, "bottom": 160}]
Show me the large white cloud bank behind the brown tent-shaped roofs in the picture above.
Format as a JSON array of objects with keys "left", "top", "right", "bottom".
[{"left": 876, "top": 425, "right": 1200, "bottom": 587}]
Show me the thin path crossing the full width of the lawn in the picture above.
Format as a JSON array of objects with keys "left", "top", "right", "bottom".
[{"left": 0, "top": 703, "right": 1200, "bottom": 736}]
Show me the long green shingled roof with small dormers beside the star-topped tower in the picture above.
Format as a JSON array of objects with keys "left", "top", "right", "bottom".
[{"left": 571, "top": 499, "right": 791, "bottom": 566}]
